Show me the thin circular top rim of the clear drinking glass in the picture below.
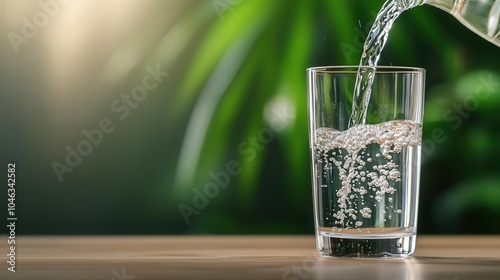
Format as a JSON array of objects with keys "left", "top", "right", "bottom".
[{"left": 306, "top": 65, "right": 425, "bottom": 74}]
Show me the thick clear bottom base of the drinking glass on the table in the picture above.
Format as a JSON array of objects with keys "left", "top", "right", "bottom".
[{"left": 317, "top": 235, "right": 417, "bottom": 258}]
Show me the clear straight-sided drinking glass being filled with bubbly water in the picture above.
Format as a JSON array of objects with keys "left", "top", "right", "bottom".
[{"left": 307, "top": 66, "right": 425, "bottom": 257}]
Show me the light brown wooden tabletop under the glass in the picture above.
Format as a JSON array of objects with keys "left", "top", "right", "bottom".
[{"left": 0, "top": 236, "right": 500, "bottom": 280}]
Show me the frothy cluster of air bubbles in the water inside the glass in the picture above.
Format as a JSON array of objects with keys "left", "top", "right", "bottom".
[{"left": 313, "top": 121, "right": 422, "bottom": 228}]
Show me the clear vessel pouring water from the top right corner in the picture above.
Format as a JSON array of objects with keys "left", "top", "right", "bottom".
[{"left": 403, "top": 0, "right": 500, "bottom": 47}]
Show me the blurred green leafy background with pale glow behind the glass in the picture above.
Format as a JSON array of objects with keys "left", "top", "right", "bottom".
[{"left": 0, "top": 0, "right": 500, "bottom": 234}]
